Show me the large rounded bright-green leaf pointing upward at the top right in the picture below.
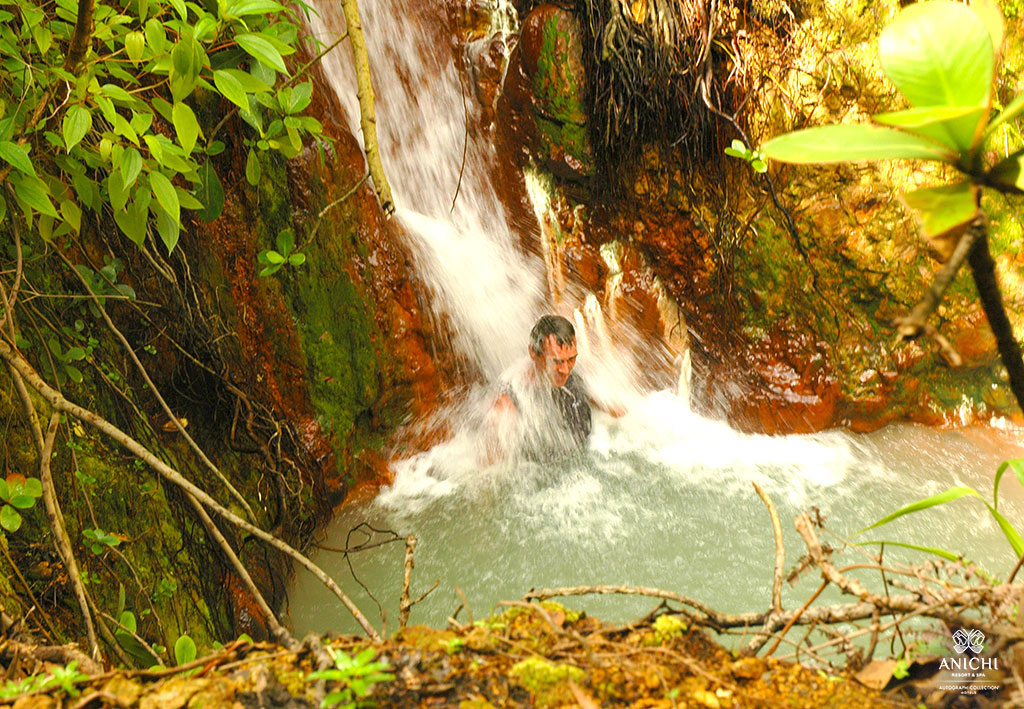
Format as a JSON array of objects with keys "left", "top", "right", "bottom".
[{"left": 879, "top": 0, "right": 995, "bottom": 107}]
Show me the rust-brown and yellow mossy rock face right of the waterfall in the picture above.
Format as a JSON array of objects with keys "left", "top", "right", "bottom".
[{"left": 477, "top": 2, "right": 1024, "bottom": 433}]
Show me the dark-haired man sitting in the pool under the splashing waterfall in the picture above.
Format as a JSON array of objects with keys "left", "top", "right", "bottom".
[{"left": 486, "top": 315, "right": 592, "bottom": 462}]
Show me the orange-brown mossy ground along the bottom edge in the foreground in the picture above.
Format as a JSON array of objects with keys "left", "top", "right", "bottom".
[{"left": 2, "top": 603, "right": 929, "bottom": 709}]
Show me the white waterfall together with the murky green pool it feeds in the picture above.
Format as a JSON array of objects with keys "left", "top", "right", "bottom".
[{"left": 289, "top": 0, "right": 1024, "bottom": 636}]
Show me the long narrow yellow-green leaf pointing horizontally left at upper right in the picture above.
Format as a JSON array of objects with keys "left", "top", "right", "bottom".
[{"left": 761, "top": 124, "right": 956, "bottom": 164}]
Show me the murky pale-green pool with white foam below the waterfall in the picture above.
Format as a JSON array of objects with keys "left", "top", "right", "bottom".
[{"left": 290, "top": 392, "right": 1024, "bottom": 635}]
